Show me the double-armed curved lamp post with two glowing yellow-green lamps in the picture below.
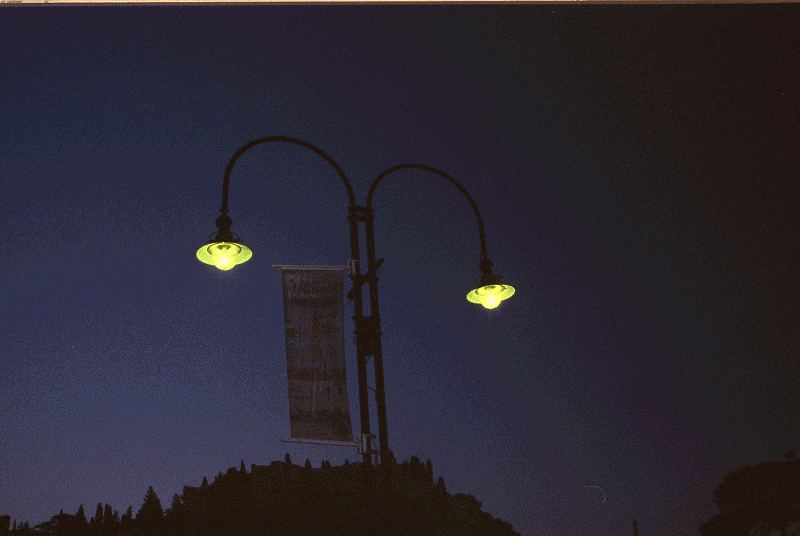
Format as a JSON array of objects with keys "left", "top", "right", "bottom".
[{"left": 197, "top": 136, "right": 514, "bottom": 464}]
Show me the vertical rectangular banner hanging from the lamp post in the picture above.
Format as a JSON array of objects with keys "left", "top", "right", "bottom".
[{"left": 276, "top": 266, "right": 353, "bottom": 442}]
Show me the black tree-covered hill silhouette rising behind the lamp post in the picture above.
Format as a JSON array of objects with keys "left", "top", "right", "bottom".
[{"left": 0, "top": 454, "right": 519, "bottom": 536}]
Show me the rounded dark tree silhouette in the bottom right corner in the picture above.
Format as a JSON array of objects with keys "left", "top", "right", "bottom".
[{"left": 700, "top": 452, "right": 800, "bottom": 536}]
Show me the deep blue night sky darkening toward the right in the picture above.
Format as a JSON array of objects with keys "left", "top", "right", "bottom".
[{"left": 0, "top": 5, "right": 800, "bottom": 536}]
